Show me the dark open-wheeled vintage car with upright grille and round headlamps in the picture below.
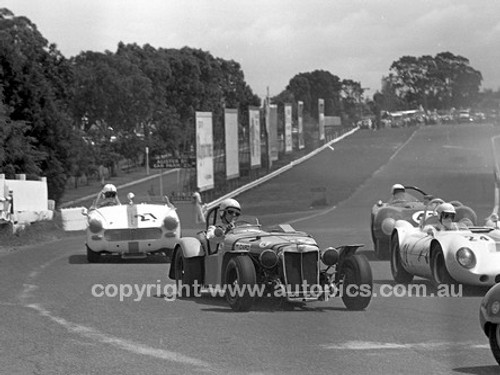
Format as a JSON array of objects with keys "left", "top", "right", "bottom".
[{"left": 169, "top": 206, "right": 372, "bottom": 311}]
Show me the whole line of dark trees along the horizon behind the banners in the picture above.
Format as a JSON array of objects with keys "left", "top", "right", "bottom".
[{"left": 0, "top": 8, "right": 496, "bottom": 202}]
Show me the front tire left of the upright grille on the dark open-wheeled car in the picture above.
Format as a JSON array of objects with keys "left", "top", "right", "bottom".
[{"left": 224, "top": 256, "right": 257, "bottom": 312}]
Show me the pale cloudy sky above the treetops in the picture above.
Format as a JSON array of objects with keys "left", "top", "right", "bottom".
[{"left": 0, "top": 0, "right": 500, "bottom": 98}]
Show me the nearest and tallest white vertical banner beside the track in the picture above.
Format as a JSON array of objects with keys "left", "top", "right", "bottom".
[{"left": 196, "top": 112, "right": 214, "bottom": 191}]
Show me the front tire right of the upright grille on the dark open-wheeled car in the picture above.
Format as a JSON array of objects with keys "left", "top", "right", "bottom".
[{"left": 341, "top": 254, "right": 373, "bottom": 310}]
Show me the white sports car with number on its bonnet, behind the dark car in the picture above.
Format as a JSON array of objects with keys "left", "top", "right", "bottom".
[{"left": 83, "top": 193, "right": 181, "bottom": 263}]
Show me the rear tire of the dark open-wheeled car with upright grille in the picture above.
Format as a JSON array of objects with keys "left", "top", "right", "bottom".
[{"left": 174, "top": 249, "right": 202, "bottom": 298}]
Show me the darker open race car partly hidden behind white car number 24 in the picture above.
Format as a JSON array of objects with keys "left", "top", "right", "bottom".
[{"left": 370, "top": 186, "right": 477, "bottom": 259}]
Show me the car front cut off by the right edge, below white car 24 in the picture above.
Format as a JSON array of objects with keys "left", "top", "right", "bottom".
[{"left": 479, "top": 284, "right": 500, "bottom": 365}]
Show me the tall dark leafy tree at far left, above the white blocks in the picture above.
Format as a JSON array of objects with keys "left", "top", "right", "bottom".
[{"left": 0, "top": 8, "right": 76, "bottom": 202}]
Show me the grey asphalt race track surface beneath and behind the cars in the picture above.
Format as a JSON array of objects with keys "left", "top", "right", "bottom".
[{"left": 0, "top": 124, "right": 500, "bottom": 375}]
